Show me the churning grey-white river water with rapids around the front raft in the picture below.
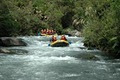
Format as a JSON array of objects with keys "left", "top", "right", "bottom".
[{"left": 0, "top": 36, "right": 120, "bottom": 80}]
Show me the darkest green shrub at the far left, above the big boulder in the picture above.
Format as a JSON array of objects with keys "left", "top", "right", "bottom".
[{"left": 0, "top": 1, "right": 20, "bottom": 37}]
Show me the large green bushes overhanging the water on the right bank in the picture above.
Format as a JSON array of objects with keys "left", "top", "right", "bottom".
[{"left": 83, "top": 0, "right": 120, "bottom": 57}]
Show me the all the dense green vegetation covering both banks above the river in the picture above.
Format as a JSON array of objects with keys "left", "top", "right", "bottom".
[{"left": 0, "top": 0, "right": 120, "bottom": 57}]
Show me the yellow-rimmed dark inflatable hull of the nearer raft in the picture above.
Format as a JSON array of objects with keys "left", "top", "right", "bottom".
[{"left": 50, "top": 40, "right": 69, "bottom": 47}]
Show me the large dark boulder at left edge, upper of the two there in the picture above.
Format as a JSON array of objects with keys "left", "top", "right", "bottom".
[{"left": 0, "top": 37, "right": 27, "bottom": 47}]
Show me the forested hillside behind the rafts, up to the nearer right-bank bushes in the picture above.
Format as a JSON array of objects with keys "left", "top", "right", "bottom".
[{"left": 0, "top": 0, "right": 84, "bottom": 36}]
